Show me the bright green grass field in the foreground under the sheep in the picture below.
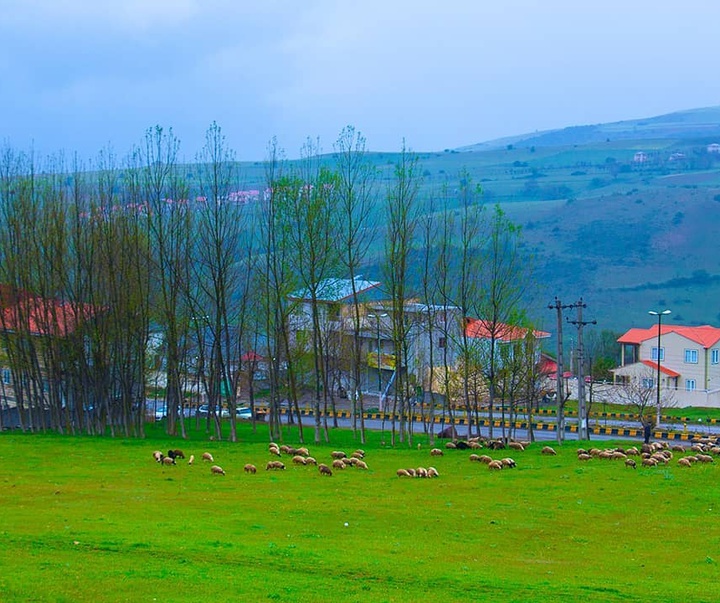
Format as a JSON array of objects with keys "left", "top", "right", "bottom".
[{"left": 0, "top": 425, "right": 720, "bottom": 603}]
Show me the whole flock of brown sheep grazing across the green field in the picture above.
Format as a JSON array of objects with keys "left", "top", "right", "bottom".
[{"left": 152, "top": 438, "right": 720, "bottom": 478}]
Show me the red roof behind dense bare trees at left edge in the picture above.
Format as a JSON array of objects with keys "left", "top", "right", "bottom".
[{"left": 0, "top": 285, "right": 97, "bottom": 337}]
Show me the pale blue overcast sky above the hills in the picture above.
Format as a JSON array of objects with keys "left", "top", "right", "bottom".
[{"left": 0, "top": 0, "right": 720, "bottom": 160}]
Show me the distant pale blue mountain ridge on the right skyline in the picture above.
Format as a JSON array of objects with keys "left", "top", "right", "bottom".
[{"left": 456, "top": 106, "right": 720, "bottom": 152}]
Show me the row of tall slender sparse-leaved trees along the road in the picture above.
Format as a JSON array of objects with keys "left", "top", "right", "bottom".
[{"left": 0, "top": 124, "right": 537, "bottom": 443}]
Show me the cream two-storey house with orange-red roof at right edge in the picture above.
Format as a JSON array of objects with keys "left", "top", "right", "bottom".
[{"left": 613, "top": 325, "right": 720, "bottom": 407}]
